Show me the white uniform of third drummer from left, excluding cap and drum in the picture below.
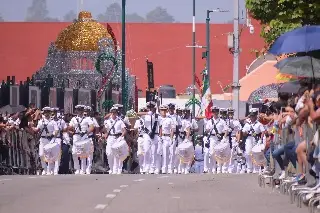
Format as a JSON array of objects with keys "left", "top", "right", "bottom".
[{"left": 104, "top": 117, "right": 126, "bottom": 174}]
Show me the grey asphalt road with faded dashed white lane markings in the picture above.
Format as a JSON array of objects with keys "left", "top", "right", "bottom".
[{"left": 0, "top": 174, "right": 307, "bottom": 213}]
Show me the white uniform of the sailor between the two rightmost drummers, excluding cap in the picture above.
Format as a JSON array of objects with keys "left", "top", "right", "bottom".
[{"left": 226, "top": 119, "right": 242, "bottom": 173}]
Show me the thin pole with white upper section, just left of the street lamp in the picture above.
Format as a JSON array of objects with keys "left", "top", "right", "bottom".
[{"left": 192, "top": 0, "right": 196, "bottom": 117}]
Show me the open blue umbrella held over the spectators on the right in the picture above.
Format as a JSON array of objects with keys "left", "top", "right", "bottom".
[{"left": 269, "top": 25, "right": 320, "bottom": 55}]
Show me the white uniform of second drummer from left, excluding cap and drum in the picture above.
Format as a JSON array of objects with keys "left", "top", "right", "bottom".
[{"left": 69, "top": 116, "right": 93, "bottom": 174}]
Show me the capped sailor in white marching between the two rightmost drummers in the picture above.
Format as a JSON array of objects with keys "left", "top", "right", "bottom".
[{"left": 226, "top": 108, "right": 242, "bottom": 173}]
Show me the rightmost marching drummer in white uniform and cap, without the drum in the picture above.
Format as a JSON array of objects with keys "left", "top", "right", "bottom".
[{"left": 242, "top": 108, "right": 265, "bottom": 173}]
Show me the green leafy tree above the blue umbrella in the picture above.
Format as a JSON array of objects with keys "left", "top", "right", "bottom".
[{"left": 246, "top": 0, "right": 320, "bottom": 46}]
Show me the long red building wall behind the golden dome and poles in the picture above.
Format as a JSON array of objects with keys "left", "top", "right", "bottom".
[{"left": 0, "top": 18, "right": 264, "bottom": 93}]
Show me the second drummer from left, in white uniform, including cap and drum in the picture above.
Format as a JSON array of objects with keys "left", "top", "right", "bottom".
[{"left": 69, "top": 105, "right": 94, "bottom": 175}]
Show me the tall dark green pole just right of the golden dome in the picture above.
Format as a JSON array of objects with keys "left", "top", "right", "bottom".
[{"left": 121, "top": 0, "right": 128, "bottom": 112}]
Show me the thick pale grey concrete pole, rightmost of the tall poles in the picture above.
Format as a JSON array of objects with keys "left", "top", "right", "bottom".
[{"left": 232, "top": 0, "right": 240, "bottom": 119}]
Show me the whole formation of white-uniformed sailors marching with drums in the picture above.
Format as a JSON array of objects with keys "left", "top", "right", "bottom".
[{"left": 33, "top": 101, "right": 265, "bottom": 175}]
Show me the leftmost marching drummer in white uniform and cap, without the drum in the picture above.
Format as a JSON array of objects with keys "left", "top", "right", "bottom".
[{"left": 33, "top": 107, "right": 59, "bottom": 175}]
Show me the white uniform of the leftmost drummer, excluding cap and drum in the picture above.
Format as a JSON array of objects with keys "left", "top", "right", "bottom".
[{"left": 36, "top": 118, "right": 59, "bottom": 175}]
